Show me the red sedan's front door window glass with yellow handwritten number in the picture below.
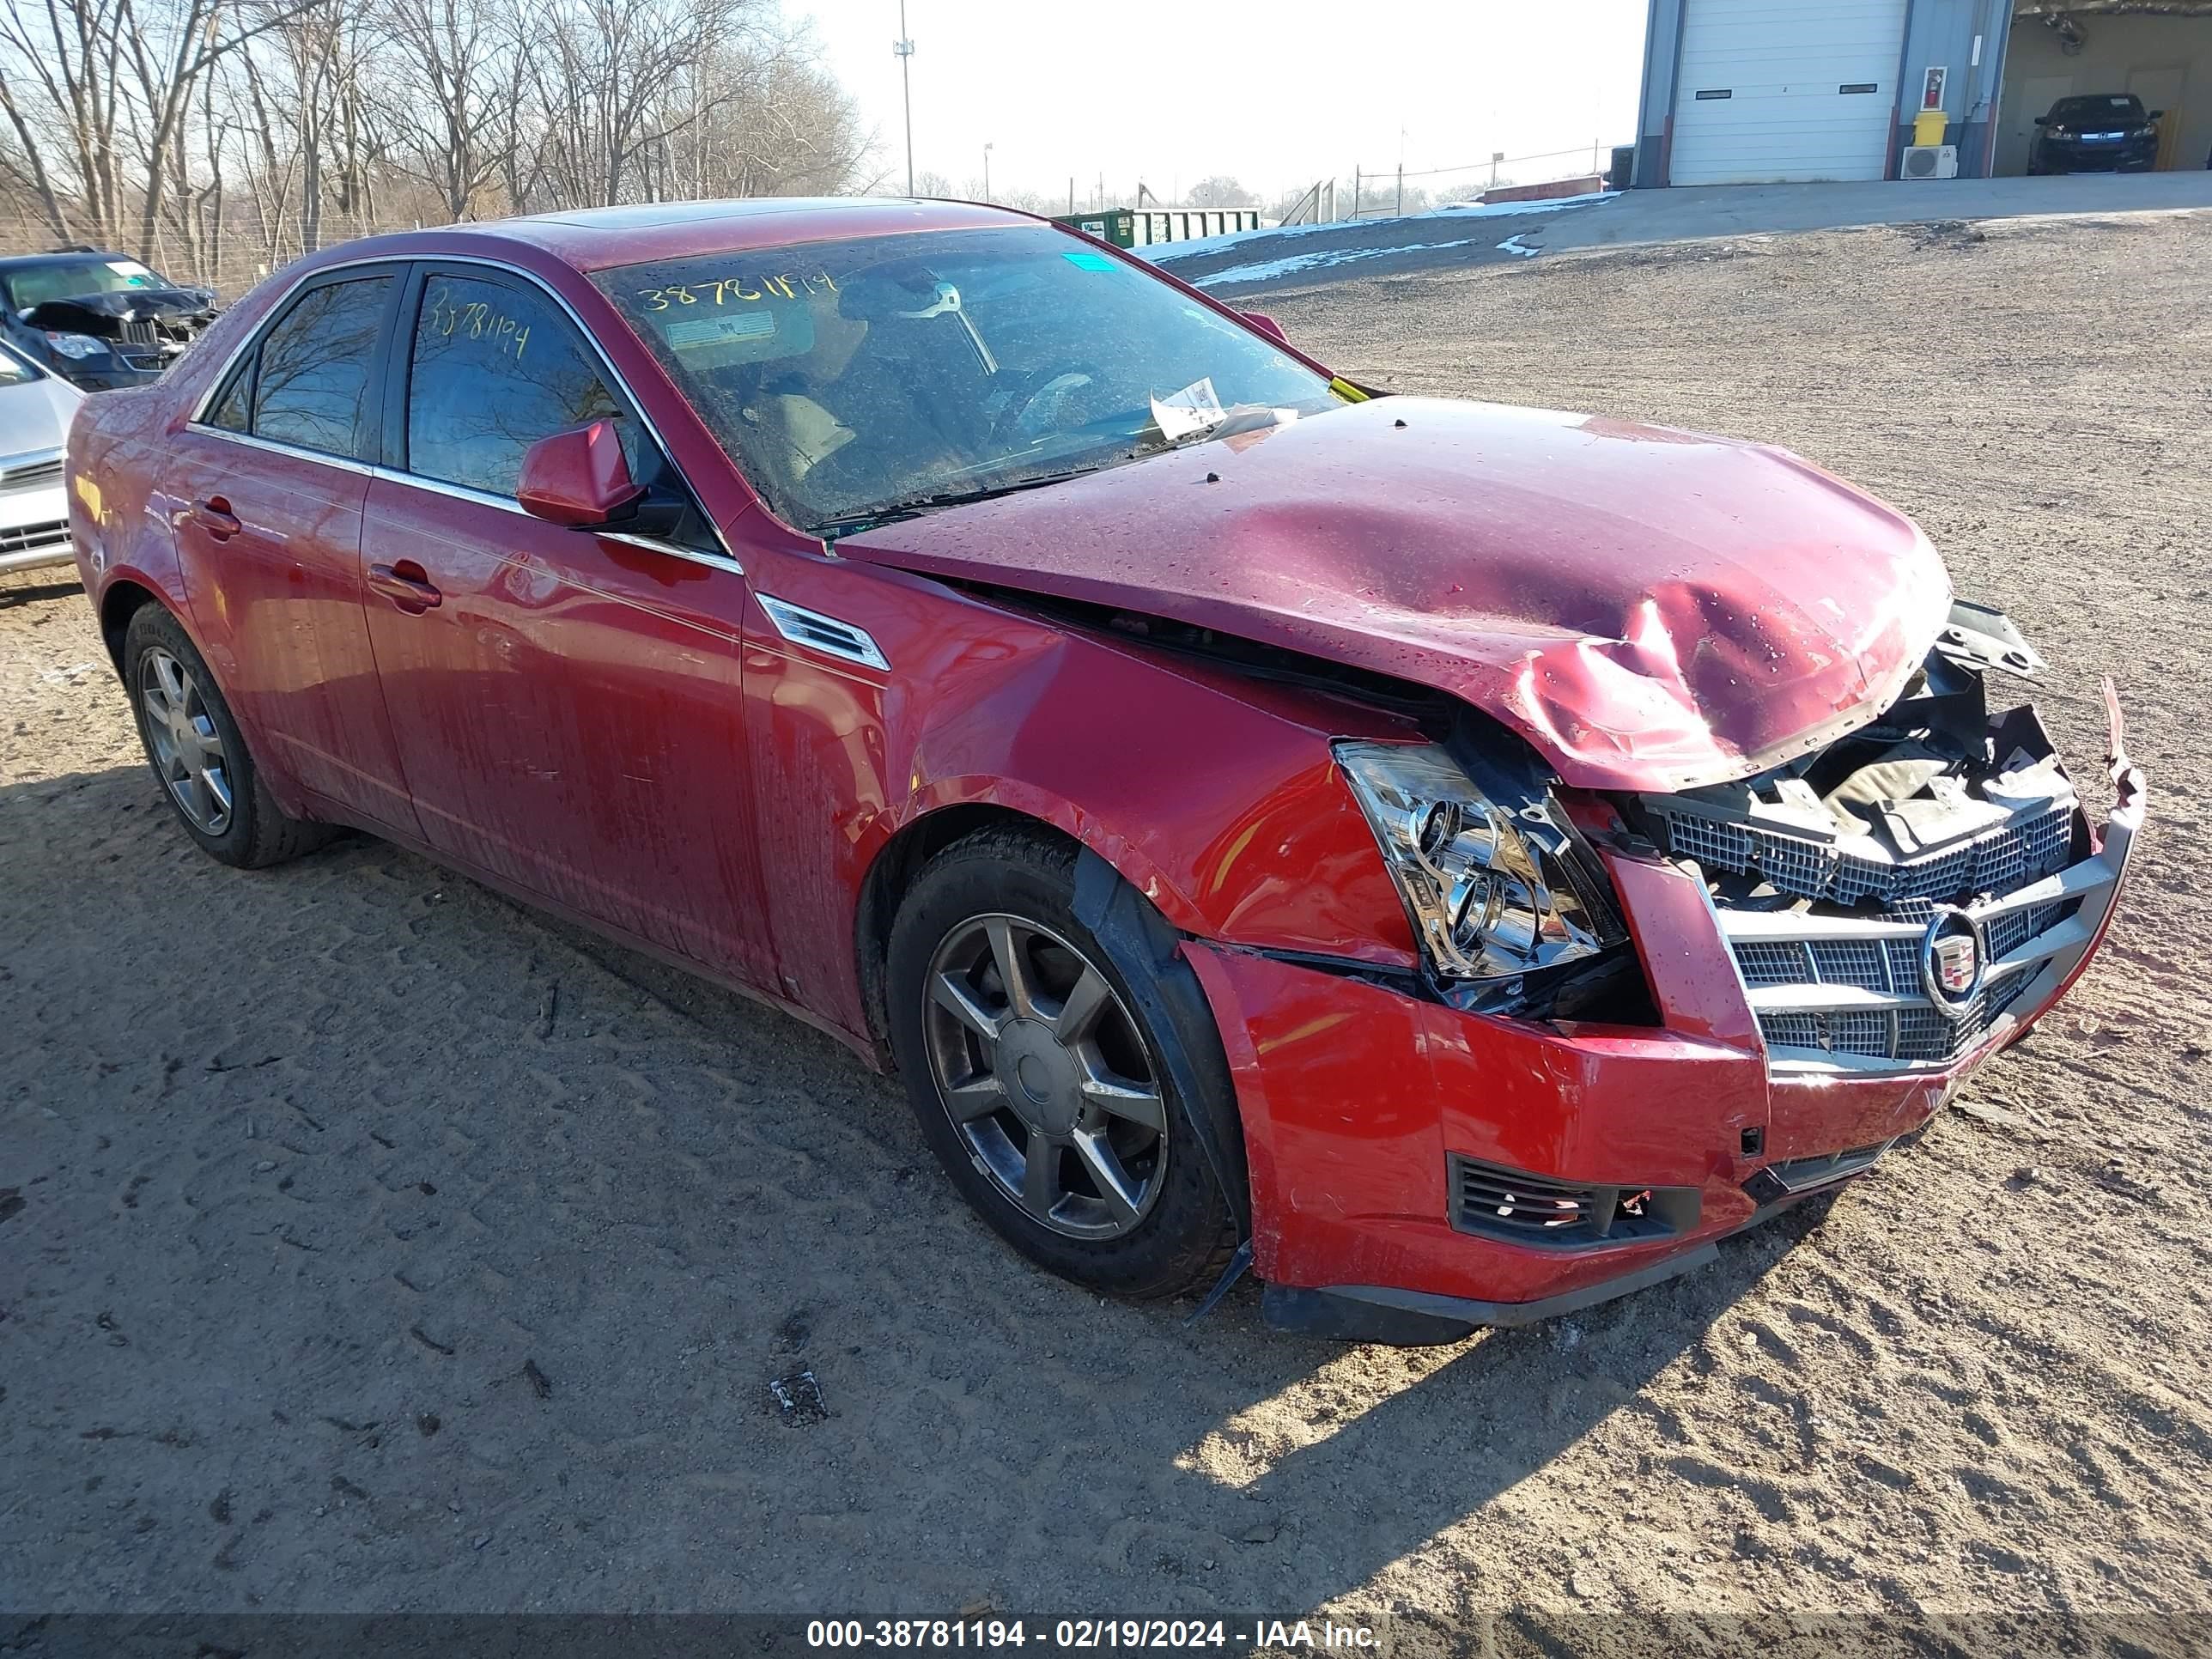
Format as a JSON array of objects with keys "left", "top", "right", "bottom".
[{"left": 407, "top": 274, "right": 644, "bottom": 495}]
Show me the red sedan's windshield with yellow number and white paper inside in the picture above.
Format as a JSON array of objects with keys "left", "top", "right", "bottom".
[{"left": 595, "top": 226, "right": 1340, "bottom": 533}]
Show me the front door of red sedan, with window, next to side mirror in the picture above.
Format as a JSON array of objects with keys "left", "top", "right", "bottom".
[{"left": 362, "top": 264, "right": 769, "bottom": 984}]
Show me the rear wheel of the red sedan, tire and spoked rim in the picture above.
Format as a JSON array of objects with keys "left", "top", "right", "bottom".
[{"left": 124, "top": 604, "right": 337, "bottom": 869}]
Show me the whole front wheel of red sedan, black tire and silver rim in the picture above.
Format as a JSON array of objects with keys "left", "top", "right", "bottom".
[{"left": 890, "top": 830, "right": 1237, "bottom": 1298}]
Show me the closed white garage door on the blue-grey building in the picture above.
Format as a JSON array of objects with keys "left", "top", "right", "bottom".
[{"left": 1668, "top": 0, "right": 1907, "bottom": 184}]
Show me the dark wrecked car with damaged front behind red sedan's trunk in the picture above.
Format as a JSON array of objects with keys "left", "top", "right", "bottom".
[{"left": 0, "top": 248, "right": 215, "bottom": 392}]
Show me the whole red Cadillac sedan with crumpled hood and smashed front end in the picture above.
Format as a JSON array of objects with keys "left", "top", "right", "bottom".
[{"left": 69, "top": 201, "right": 2143, "bottom": 1343}]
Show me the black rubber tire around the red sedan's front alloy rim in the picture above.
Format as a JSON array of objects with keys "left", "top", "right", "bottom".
[{"left": 887, "top": 827, "right": 1239, "bottom": 1301}]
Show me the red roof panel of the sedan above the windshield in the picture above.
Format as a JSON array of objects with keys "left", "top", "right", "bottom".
[{"left": 323, "top": 197, "right": 1044, "bottom": 272}]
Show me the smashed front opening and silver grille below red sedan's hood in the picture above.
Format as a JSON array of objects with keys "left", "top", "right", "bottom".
[{"left": 1620, "top": 604, "right": 2139, "bottom": 1071}]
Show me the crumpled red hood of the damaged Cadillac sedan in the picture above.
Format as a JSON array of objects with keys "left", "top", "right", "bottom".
[{"left": 836, "top": 398, "right": 1951, "bottom": 790}]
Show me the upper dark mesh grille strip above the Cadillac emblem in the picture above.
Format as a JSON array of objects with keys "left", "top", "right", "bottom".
[{"left": 1662, "top": 801, "right": 2075, "bottom": 905}]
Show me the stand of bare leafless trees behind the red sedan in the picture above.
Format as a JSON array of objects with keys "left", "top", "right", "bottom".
[{"left": 0, "top": 0, "right": 876, "bottom": 285}]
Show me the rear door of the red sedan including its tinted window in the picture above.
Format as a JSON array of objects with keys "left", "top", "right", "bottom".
[{"left": 164, "top": 265, "right": 416, "bottom": 834}]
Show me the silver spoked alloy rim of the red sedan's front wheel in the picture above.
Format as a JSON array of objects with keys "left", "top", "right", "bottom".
[{"left": 925, "top": 915, "right": 1168, "bottom": 1239}]
